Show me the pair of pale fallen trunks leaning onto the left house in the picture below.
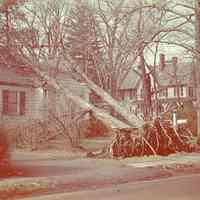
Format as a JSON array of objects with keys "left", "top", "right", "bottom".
[{"left": 20, "top": 61, "right": 156, "bottom": 155}]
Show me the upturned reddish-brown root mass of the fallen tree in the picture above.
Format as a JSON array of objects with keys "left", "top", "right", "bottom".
[{"left": 88, "top": 119, "right": 200, "bottom": 158}]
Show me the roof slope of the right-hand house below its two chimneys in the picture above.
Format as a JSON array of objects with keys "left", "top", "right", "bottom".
[{"left": 156, "top": 62, "right": 194, "bottom": 86}]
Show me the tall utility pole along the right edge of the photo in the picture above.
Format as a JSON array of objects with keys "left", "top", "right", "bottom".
[{"left": 195, "top": 0, "right": 200, "bottom": 135}]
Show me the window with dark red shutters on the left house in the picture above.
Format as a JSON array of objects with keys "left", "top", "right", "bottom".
[{"left": 2, "top": 90, "right": 26, "bottom": 116}]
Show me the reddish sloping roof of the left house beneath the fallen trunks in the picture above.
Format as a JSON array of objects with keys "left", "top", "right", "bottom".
[{"left": 0, "top": 47, "right": 87, "bottom": 90}]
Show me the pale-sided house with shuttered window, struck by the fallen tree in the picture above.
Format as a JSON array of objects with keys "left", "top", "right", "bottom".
[{"left": 0, "top": 51, "right": 89, "bottom": 126}]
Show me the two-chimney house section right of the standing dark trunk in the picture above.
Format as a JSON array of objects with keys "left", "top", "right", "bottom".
[{"left": 152, "top": 54, "right": 196, "bottom": 115}]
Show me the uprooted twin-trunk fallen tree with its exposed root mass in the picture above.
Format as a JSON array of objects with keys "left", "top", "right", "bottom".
[{"left": 3, "top": 48, "right": 198, "bottom": 157}]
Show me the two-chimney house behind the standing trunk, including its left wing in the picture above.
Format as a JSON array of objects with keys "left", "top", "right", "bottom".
[{"left": 119, "top": 54, "right": 196, "bottom": 130}]
